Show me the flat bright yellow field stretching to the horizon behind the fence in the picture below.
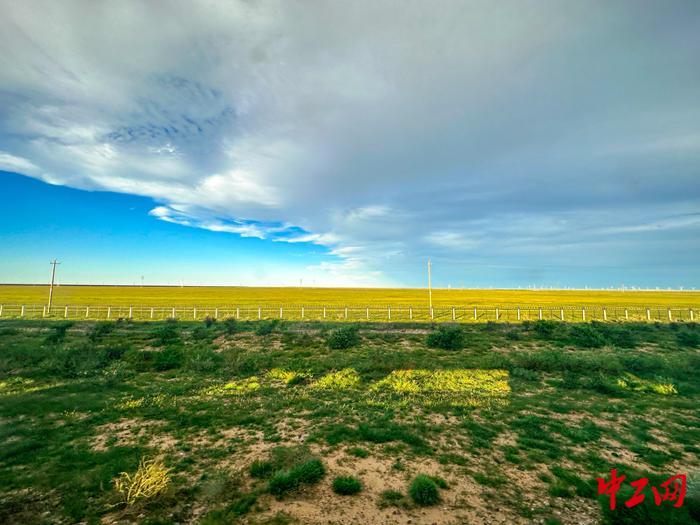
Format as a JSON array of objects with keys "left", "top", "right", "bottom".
[{"left": 0, "top": 285, "right": 700, "bottom": 307}]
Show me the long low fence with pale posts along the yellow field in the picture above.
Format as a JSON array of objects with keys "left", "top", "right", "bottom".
[{"left": 0, "top": 304, "right": 700, "bottom": 323}]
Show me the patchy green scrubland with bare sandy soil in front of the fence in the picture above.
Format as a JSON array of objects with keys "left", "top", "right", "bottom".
[{"left": 0, "top": 320, "right": 700, "bottom": 525}]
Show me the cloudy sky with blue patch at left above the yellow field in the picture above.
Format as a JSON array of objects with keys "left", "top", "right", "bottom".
[{"left": 0, "top": 0, "right": 700, "bottom": 288}]
